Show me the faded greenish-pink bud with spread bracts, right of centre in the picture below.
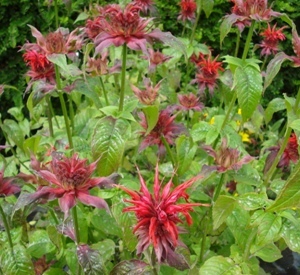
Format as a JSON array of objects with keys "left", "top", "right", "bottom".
[{"left": 203, "top": 139, "right": 254, "bottom": 173}]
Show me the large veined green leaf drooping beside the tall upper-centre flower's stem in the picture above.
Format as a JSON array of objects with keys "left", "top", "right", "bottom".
[{"left": 92, "top": 117, "right": 130, "bottom": 176}]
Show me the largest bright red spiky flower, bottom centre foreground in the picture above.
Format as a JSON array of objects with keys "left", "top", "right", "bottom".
[{"left": 118, "top": 165, "right": 208, "bottom": 265}]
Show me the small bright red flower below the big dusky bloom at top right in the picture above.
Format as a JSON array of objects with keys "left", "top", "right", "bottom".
[{"left": 259, "top": 23, "right": 286, "bottom": 55}]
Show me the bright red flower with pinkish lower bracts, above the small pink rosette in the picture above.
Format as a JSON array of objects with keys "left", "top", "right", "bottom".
[{"left": 192, "top": 54, "right": 224, "bottom": 93}]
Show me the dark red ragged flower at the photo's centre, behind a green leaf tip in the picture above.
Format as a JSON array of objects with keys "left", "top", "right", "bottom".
[{"left": 140, "top": 109, "right": 184, "bottom": 155}]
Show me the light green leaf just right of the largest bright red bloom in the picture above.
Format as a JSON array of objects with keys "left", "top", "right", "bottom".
[{"left": 213, "top": 195, "right": 236, "bottom": 230}]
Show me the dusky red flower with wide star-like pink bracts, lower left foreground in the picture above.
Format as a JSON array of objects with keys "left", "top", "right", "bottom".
[{"left": 26, "top": 154, "right": 112, "bottom": 218}]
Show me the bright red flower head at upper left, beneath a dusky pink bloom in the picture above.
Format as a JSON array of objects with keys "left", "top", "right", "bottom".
[{"left": 23, "top": 50, "right": 55, "bottom": 81}]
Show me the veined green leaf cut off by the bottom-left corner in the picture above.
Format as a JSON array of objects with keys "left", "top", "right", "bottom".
[{"left": 0, "top": 245, "right": 35, "bottom": 275}]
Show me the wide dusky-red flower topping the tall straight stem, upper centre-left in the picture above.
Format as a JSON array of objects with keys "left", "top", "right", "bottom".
[{"left": 95, "top": 3, "right": 170, "bottom": 55}]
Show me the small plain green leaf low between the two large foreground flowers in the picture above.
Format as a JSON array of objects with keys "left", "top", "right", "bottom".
[{"left": 91, "top": 209, "right": 122, "bottom": 237}]
